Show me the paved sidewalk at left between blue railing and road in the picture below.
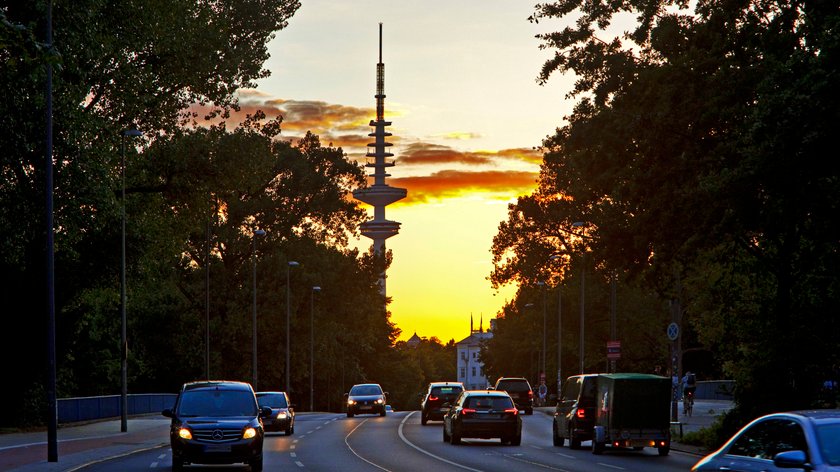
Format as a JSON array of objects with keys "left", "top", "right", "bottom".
[{"left": 0, "top": 415, "right": 170, "bottom": 472}]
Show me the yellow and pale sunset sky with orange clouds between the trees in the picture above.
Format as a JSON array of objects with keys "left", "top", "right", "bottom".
[{"left": 246, "top": 0, "right": 571, "bottom": 342}]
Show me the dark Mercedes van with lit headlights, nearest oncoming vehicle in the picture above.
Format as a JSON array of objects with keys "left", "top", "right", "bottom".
[{"left": 163, "top": 381, "right": 271, "bottom": 472}]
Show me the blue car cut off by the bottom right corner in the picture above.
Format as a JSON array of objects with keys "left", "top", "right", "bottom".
[{"left": 691, "top": 410, "right": 840, "bottom": 472}]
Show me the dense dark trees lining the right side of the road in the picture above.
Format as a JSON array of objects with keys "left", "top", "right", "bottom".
[{"left": 492, "top": 0, "right": 840, "bottom": 430}]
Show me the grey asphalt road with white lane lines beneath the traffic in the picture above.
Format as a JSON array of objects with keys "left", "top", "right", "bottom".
[{"left": 79, "top": 412, "right": 699, "bottom": 472}]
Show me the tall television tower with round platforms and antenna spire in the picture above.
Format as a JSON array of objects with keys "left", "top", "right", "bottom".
[{"left": 353, "top": 23, "right": 408, "bottom": 296}]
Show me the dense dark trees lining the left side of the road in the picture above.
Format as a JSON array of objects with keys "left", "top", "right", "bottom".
[{"left": 0, "top": 0, "right": 454, "bottom": 425}]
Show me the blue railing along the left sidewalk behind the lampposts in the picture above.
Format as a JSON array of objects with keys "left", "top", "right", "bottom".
[{"left": 58, "top": 393, "right": 178, "bottom": 423}]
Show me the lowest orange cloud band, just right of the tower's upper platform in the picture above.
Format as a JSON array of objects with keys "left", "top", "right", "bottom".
[{"left": 388, "top": 170, "right": 538, "bottom": 204}]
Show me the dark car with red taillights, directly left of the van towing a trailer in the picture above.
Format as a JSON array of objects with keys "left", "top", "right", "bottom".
[{"left": 443, "top": 390, "right": 522, "bottom": 446}]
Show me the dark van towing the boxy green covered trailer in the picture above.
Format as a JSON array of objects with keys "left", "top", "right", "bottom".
[{"left": 552, "top": 374, "right": 598, "bottom": 449}]
